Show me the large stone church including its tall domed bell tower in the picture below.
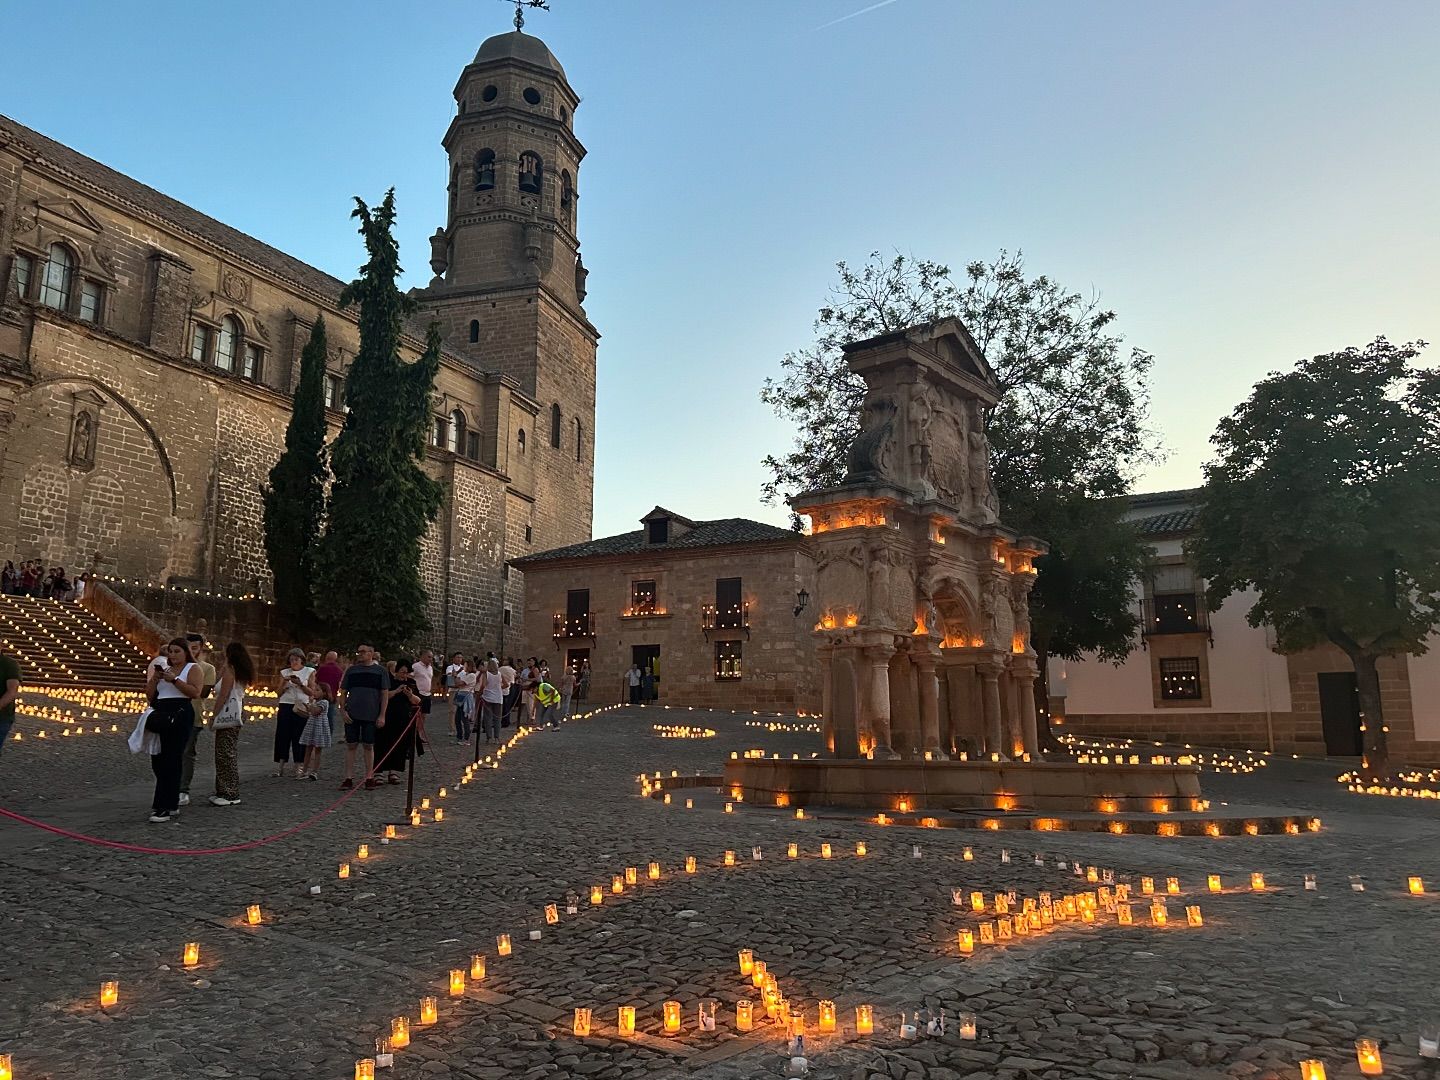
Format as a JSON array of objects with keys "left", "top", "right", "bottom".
[{"left": 0, "top": 30, "right": 599, "bottom": 647}]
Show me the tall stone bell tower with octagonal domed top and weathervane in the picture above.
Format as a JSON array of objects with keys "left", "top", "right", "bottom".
[{"left": 413, "top": 19, "right": 599, "bottom": 557}]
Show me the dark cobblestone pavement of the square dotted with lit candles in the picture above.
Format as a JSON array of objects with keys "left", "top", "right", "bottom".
[{"left": 0, "top": 708, "right": 1440, "bottom": 1080}]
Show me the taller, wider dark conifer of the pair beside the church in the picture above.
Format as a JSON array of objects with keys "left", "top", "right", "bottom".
[{"left": 320, "top": 189, "right": 444, "bottom": 651}]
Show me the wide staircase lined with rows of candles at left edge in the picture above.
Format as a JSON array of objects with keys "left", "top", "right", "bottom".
[{"left": 0, "top": 596, "right": 150, "bottom": 690}]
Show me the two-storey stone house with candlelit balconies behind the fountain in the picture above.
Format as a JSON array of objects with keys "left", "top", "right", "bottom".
[{"left": 511, "top": 507, "right": 819, "bottom": 711}]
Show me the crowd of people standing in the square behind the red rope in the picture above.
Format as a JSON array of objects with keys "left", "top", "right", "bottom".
[{"left": 129, "top": 634, "right": 590, "bottom": 824}]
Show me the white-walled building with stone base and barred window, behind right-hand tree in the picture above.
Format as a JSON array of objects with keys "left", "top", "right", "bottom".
[{"left": 1048, "top": 488, "right": 1440, "bottom": 762}]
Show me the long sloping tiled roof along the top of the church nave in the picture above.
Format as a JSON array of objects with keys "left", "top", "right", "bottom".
[{"left": 0, "top": 115, "right": 454, "bottom": 356}]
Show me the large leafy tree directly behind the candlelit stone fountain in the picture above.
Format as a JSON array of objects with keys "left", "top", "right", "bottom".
[{"left": 760, "top": 251, "right": 1155, "bottom": 742}]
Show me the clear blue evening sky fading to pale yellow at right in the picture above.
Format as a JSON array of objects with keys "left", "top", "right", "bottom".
[{"left": 0, "top": 0, "right": 1440, "bottom": 536}]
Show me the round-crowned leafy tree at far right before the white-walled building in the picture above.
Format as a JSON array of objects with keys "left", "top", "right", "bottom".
[{"left": 1189, "top": 337, "right": 1440, "bottom": 776}]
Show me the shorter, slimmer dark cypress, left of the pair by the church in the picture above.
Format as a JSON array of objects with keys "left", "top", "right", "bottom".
[{"left": 261, "top": 318, "right": 328, "bottom": 632}]
